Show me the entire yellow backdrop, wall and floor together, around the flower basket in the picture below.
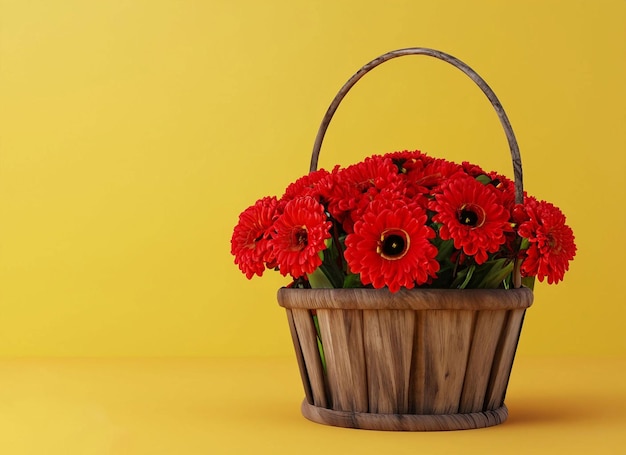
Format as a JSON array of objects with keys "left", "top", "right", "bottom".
[{"left": 0, "top": 0, "right": 626, "bottom": 455}]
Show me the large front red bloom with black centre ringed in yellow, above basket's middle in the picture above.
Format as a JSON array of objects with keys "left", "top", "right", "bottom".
[{"left": 345, "top": 198, "right": 439, "bottom": 292}]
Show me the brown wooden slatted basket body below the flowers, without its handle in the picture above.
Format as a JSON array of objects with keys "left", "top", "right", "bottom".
[{"left": 278, "top": 287, "right": 533, "bottom": 431}]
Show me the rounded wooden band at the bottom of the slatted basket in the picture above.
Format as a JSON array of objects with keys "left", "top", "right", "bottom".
[{"left": 302, "top": 399, "right": 509, "bottom": 431}]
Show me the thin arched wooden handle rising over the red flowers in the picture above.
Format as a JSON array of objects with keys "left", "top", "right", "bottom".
[{"left": 309, "top": 47, "right": 524, "bottom": 204}]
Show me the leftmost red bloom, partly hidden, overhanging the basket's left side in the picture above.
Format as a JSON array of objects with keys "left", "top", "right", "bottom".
[{"left": 230, "top": 197, "right": 278, "bottom": 279}]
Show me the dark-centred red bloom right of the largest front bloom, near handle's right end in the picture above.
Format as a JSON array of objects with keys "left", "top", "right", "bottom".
[{"left": 429, "top": 175, "right": 511, "bottom": 264}]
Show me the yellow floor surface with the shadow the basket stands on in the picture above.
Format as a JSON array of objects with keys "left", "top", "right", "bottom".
[{"left": 0, "top": 358, "right": 626, "bottom": 455}]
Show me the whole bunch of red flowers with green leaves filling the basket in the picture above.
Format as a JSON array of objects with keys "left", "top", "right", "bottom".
[{"left": 231, "top": 151, "right": 576, "bottom": 292}]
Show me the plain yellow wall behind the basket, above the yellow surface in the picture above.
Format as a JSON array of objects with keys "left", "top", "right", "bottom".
[{"left": 0, "top": 0, "right": 626, "bottom": 357}]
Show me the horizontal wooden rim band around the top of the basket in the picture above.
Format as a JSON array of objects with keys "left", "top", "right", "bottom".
[{"left": 277, "top": 287, "right": 534, "bottom": 310}]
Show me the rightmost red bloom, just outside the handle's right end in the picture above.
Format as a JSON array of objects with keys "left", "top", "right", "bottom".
[{"left": 518, "top": 197, "right": 576, "bottom": 284}]
